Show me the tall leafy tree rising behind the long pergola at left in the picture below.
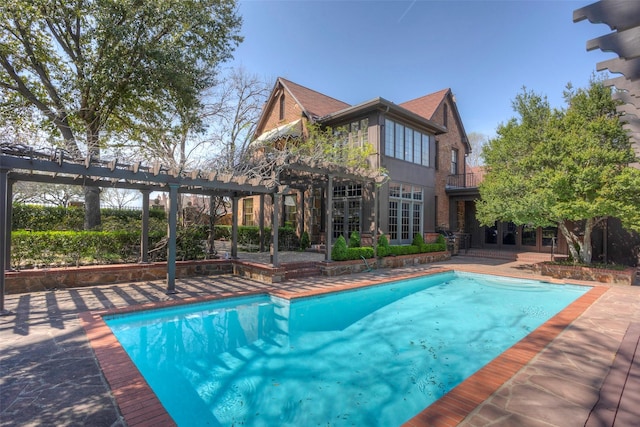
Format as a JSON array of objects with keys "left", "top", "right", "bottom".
[{"left": 0, "top": 0, "right": 242, "bottom": 228}]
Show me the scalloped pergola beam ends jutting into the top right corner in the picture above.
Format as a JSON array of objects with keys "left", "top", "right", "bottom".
[{"left": 573, "top": 0, "right": 640, "bottom": 150}]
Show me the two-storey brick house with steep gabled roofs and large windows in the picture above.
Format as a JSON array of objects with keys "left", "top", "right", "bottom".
[{"left": 238, "top": 78, "right": 471, "bottom": 244}]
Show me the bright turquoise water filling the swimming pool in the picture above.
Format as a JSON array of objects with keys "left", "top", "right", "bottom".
[{"left": 105, "top": 272, "right": 589, "bottom": 426}]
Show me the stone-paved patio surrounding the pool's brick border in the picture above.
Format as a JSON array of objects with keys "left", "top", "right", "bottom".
[{"left": 0, "top": 256, "right": 640, "bottom": 426}]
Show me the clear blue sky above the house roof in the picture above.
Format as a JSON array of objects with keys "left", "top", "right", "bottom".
[{"left": 230, "top": 0, "right": 615, "bottom": 136}]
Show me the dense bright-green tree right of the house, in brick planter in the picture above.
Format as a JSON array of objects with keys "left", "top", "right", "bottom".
[{"left": 477, "top": 79, "right": 640, "bottom": 264}]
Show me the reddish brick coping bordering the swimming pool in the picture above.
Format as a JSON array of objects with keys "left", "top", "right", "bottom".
[{"left": 79, "top": 268, "right": 608, "bottom": 427}]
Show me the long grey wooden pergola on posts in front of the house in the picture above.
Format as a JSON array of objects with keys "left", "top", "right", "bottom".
[{"left": 0, "top": 144, "right": 383, "bottom": 313}]
